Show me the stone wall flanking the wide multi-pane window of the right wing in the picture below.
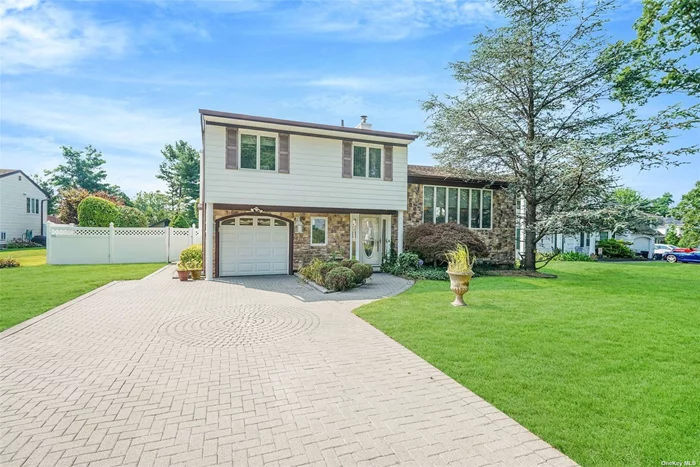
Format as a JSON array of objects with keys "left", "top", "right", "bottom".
[{"left": 404, "top": 183, "right": 515, "bottom": 265}]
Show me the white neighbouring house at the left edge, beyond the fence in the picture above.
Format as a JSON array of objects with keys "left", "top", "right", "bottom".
[{"left": 0, "top": 169, "right": 47, "bottom": 245}]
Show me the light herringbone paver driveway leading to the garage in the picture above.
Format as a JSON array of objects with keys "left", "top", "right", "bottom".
[{"left": 0, "top": 268, "right": 574, "bottom": 467}]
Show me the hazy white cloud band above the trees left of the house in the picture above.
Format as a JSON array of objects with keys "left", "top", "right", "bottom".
[{"left": 0, "top": 93, "right": 201, "bottom": 195}]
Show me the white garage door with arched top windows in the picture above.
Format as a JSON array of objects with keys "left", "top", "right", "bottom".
[{"left": 219, "top": 216, "right": 289, "bottom": 276}]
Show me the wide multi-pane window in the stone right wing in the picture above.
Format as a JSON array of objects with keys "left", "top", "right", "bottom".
[{"left": 423, "top": 185, "right": 493, "bottom": 229}]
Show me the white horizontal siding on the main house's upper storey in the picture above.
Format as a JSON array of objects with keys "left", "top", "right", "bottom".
[{"left": 204, "top": 125, "right": 408, "bottom": 210}]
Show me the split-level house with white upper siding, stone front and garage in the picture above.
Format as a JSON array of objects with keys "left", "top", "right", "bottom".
[{"left": 200, "top": 110, "right": 514, "bottom": 279}]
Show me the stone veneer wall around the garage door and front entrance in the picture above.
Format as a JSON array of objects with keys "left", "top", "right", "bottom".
[{"left": 209, "top": 209, "right": 350, "bottom": 271}]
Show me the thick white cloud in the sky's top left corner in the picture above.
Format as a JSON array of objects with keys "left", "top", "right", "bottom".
[{"left": 0, "top": 0, "right": 128, "bottom": 74}]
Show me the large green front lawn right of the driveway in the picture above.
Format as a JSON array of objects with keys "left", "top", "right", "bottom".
[{"left": 357, "top": 262, "right": 700, "bottom": 466}]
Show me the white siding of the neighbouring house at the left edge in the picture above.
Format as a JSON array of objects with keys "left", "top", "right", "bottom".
[{"left": 0, "top": 174, "right": 46, "bottom": 240}]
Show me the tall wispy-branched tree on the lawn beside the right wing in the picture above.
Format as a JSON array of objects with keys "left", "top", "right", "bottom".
[{"left": 422, "top": 0, "right": 693, "bottom": 270}]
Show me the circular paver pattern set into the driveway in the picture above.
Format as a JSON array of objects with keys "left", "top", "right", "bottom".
[{"left": 158, "top": 305, "right": 319, "bottom": 348}]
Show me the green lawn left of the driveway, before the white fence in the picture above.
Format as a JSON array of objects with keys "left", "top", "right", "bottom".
[{"left": 0, "top": 248, "right": 163, "bottom": 331}]
